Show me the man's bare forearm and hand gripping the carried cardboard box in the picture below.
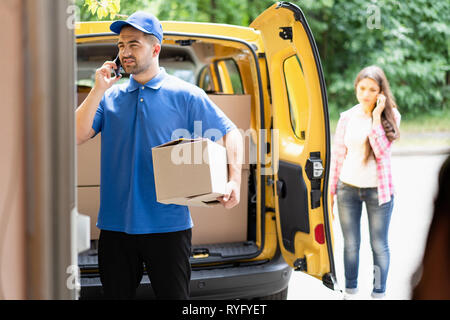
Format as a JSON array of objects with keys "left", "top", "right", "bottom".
[{"left": 217, "top": 128, "right": 244, "bottom": 209}]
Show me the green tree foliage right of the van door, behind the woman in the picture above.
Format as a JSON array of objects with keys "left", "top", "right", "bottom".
[{"left": 296, "top": 0, "right": 450, "bottom": 116}]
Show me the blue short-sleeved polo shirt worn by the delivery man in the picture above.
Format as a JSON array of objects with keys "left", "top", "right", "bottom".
[{"left": 92, "top": 68, "right": 236, "bottom": 234}]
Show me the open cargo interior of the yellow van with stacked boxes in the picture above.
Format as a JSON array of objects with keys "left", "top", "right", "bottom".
[{"left": 77, "top": 38, "right": 264, "bottom": 276}]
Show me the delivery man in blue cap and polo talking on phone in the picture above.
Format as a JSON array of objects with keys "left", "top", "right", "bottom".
[{"left": 76, "top": 12, "right": 243, "bottom": 299}]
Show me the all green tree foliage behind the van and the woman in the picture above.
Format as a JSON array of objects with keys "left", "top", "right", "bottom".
[{"left": 76, "top": 0, "right": 450, "bottom": 117}]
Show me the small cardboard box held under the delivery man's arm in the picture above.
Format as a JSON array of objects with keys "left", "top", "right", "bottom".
[{"left": 152, "top": 138, "right": 228, "bottom": 207}]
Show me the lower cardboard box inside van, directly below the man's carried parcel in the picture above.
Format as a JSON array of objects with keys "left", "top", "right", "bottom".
[{"left": 189, "top": 169, "right": 250, "bottom": 245}]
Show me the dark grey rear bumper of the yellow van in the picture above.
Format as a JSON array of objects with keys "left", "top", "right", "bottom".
[{"left": 80, "top": 255, "right": 292, "bottom": 300}]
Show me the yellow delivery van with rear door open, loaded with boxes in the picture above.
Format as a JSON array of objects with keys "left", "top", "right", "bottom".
[{"left": 76, "top": 2, "right": 336, "bottom": 299}]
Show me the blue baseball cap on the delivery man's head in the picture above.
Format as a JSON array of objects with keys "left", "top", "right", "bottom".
[{"left": 109, "top": 11, "right": 163, "bottom": 43}]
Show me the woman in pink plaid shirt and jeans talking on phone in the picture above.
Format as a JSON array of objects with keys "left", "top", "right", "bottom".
[{"left": 330, "top": 66, "right": 401, "bottom": 298}]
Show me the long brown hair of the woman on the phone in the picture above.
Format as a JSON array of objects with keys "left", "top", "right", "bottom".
[{"left": 355, "top": 66, "right": 400, "bottom": 162}]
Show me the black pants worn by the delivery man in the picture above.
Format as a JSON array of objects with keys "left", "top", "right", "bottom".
[{"left": 98, "top": 229, "right": 192, "bottom": 300}]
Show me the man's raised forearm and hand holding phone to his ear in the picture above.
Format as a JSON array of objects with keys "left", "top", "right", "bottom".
[{"left": 75, "top": 61, "right": 120, "bottom": 145}]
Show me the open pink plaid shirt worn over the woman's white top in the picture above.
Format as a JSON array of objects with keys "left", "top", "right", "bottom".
[{"left": 330, "top": 105, "right": 401, "bottom": 206}]
